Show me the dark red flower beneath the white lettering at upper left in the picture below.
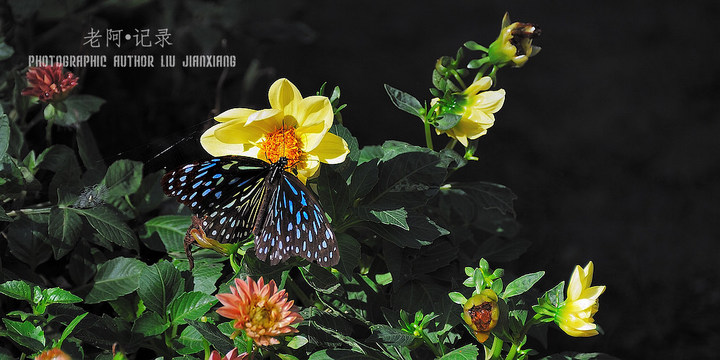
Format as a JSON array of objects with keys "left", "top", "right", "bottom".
[{"left": 21, "top": 64, "right": 78, "bottom": 102}]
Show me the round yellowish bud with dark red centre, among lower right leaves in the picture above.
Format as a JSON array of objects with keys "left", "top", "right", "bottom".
[{"left": 462, "top": 289, "right": 500, "bottom": 343}]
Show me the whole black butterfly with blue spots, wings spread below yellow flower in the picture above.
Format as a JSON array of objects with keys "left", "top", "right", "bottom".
[{"left": 162, "top": 156, "right": 339, "bottom": 266}]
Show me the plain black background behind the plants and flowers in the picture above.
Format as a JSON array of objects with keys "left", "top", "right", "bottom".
[{"left": 7, "top": 0, "right": 720, "bottom": 359}]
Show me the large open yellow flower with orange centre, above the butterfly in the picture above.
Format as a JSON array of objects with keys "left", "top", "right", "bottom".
[{"left": 200, "top": 79, "right": 350, "bottom": 183}]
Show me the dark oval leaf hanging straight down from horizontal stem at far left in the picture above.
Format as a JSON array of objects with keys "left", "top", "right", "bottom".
[{"left": 48, "top": 206, "right": 82, "bottom": 259}]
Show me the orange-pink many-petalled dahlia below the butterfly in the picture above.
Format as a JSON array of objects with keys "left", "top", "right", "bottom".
[{"left": 215, "top": 277, "right": 303, "bottom": 346}]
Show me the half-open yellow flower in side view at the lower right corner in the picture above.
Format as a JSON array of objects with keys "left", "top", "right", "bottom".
[{"left": 555, "top": 261, "right": 605, "bottom": 337}]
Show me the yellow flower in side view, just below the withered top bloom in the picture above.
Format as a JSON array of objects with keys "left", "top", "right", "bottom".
[{"left": 434, "top": 76, "right": 505, "bottom": 147}]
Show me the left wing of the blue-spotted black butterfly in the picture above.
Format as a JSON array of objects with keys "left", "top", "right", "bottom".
[{"left": 162, "top": 156, "right": 270, "bottom": 243}]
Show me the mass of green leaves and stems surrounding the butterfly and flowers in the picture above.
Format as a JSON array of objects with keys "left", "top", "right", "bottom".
[{"left": 0, "top": 4, "right": 612, "bottom": 359}]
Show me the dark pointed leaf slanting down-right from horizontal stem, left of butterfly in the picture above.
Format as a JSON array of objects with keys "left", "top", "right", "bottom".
[{"left": 74, "top": 206, "right": 138, "bottom": 251}]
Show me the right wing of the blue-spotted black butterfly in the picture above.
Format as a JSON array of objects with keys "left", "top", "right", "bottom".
[{"left": 255, "top": 171, "right": 340, "bottom": 266}]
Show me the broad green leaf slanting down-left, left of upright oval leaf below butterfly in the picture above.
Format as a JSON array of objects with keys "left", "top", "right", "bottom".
[{"left": 85, "top": 257, "right": 147, "bottom": 304}]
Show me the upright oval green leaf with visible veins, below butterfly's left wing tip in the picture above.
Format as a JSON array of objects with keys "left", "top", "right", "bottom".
[{"left": 138, "top": 261, "right": 183, "bottom": 316}]
